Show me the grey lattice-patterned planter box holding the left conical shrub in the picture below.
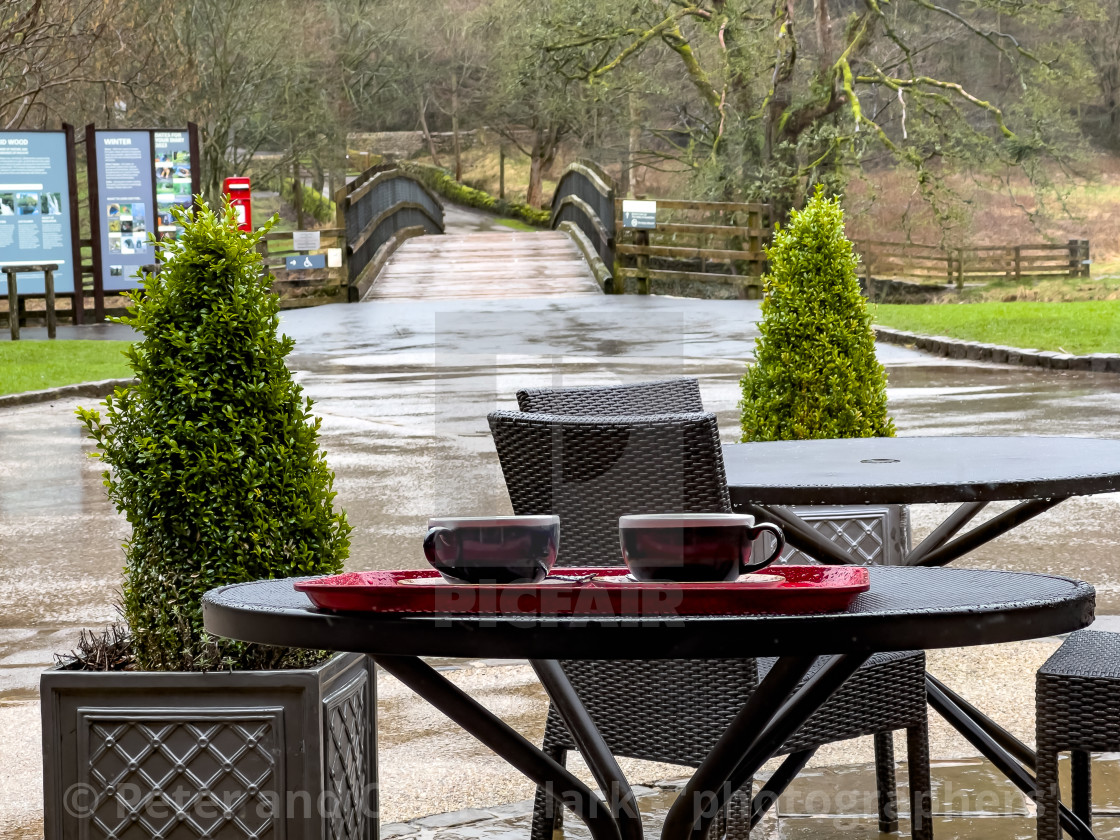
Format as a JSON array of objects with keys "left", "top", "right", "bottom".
[{"left": 40, "top": 654, "right": 377, "bottom": 840}]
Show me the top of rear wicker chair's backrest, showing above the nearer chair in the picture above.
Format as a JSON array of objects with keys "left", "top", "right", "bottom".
[{"left": 517, "top": 379, "right": 703, "bottom": 416}]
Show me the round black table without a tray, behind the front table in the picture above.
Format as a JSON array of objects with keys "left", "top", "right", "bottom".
[{"left": 724, "top": 437, "right": 1120, "bottom": 837}]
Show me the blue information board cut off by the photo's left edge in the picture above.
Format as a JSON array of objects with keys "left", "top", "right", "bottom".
[{"left": 0, "top": 131, "right": 75, "bottom": 295}]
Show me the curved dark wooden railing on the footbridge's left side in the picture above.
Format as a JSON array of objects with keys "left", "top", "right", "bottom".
[{"left": 336, "top": 166, "right": 444, "bottom": 302}]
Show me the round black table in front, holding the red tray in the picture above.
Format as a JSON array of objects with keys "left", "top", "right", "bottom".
[{"left": 203, "top": 567, "right": 1094, "bottom": 840}]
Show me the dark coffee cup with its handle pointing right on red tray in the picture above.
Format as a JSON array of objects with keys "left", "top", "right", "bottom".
[{"left": 618, "top": 513, "right": 785, "bottom": 582}]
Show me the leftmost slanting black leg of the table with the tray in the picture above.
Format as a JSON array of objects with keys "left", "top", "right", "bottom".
[{"left": 373, "top": 656, "right": 623, "bottom": 840}]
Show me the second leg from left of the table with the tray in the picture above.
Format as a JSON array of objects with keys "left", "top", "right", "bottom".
[{"left": 530, "top": 660, "right": 642, "bottom": 840}]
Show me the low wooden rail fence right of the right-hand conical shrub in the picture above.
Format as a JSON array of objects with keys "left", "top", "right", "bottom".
[{"left": 853, "top": 240, "right": 1090, "bottom": 287}]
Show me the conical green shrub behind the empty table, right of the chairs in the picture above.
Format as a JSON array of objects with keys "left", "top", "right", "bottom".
[{"left": 739, "top": 188, "right": 895, "bottom": 441}]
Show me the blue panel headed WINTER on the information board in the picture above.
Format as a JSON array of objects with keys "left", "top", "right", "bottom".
[{"left": 91, "top": 131, "right": 157, "bottom": 291}]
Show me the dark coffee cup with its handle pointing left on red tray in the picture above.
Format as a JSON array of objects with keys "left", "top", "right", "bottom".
[{"left": 423, "top": 516, "right": 560, "bottom": 584}]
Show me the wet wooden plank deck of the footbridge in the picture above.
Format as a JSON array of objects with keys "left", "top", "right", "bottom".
[{"left": 364, "top": 231, "right": 601, "bottom": 300}]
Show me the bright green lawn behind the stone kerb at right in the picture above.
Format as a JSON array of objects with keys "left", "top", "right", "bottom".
[{"left": 871, "top": 300, "right": 1120, "bottom": 355}]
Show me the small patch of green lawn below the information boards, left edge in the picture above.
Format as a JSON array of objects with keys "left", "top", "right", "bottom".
[{"left": 0, "top": 340, "right": 132, "bottom": 394}]
